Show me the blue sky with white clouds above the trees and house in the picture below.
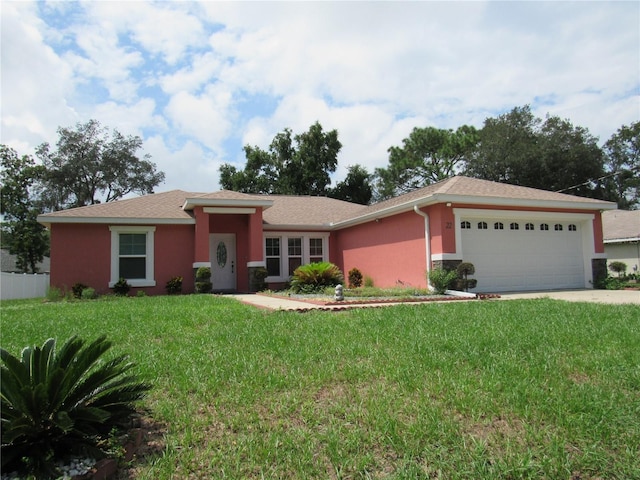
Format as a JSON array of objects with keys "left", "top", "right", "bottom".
[{"left": 0, "top": 1, "right": 640, "bottom": 192}]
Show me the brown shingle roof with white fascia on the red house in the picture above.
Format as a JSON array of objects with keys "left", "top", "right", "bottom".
[{"left": 38, "top": 176, "right": 616, "bottom": 229}]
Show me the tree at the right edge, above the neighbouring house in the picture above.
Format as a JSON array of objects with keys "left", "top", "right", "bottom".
[{"left": 603, "top": 122, "right": 640, "bottom": 210}]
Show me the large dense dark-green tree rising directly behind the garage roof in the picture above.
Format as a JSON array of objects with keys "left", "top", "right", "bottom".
[{"left": 465, "top": 105, "right": 609, "bottom": 200}]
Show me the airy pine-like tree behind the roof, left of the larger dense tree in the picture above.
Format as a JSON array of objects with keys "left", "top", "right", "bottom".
[{"left": 375, "top": 125, "right": 478, "bottom": 200}]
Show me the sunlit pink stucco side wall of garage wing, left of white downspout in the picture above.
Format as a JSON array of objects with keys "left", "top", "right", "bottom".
[{"left": 330, "top": 212, "right": 427, "bottom": 287}]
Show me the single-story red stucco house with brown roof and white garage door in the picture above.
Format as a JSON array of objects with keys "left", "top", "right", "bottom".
[{"left": 38, "top": 176, "right": 616, "bottom": 294}]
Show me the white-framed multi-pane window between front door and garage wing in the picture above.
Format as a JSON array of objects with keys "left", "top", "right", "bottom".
[{"left": 264, "top": 234, "right": 328, "bottom": 280}]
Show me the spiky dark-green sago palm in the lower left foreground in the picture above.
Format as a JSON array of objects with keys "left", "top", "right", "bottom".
[{"left": 0, "top": 336, "right": 150, "bottom": 478}]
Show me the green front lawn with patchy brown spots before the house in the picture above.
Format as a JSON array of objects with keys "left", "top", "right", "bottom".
[{"left": 1, "top": 295, "right": 640, "bottom": 479}]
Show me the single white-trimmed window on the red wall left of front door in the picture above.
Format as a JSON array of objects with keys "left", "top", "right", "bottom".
[{"left": 109, "top": 226, "right": 156, "bottom": 287}]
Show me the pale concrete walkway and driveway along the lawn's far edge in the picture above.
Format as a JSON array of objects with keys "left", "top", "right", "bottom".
[{"left": 229, "top": 290, "right": 640, "bottom": 314}]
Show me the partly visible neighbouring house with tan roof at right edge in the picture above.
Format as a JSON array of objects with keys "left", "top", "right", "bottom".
[{"left": 602, "top": 210, "right": 640, "bottom": 273}]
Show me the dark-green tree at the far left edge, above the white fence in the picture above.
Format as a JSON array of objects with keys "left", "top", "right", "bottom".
[{"left": 0, "top": 145, "right": 49, "bottom": 273}]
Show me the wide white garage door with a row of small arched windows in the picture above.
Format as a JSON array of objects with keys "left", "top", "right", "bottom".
[{"left": 460, "top": 218, "right": 585, "bottom": 292}]
